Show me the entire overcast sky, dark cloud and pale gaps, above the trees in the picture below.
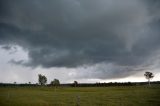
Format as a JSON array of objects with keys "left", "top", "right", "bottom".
[{"left": 0, "top": 0, "right": 160, "bottom": 83}]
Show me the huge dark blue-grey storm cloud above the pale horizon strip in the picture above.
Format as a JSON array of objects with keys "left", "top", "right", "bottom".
[{"left": 0, "top": 0, "right": 160, "bottom": 77}]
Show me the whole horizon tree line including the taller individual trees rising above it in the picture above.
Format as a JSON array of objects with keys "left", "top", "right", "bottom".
[{"left": 0, "top": 72, "right": 157, "bottom": 87}]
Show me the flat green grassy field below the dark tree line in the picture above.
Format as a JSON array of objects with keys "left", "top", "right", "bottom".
[{"left": 0, "top": 85, "right": 160, "bottom": 106}]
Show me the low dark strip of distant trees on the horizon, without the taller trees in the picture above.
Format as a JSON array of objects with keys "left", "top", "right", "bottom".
[{"left": 0, "top": 81, "right": 160, "bottom": 87}]
